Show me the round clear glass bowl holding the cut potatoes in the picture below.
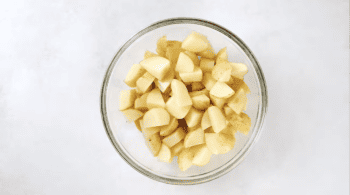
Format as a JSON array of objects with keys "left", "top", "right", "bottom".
[{"left": 101, "top": 18, "right": 268, "bottom": 185}]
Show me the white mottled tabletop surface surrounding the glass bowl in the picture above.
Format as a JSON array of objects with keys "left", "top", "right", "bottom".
[{"left": 0, "top": 0, "right": 349, "bottom": 195}]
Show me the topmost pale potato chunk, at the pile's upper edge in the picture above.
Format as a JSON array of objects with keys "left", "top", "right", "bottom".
[{"left": 181, "top": 32, "right": 209, "bottom": 52}]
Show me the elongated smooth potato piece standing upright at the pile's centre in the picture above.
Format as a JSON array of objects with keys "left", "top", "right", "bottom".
[{"left": 171, "top": 79, "right": 192, "bottom": 107}]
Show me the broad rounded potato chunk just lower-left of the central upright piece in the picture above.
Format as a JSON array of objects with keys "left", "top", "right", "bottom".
[{"left": 143, "top": 107, "right": 170, "bottom": 127}]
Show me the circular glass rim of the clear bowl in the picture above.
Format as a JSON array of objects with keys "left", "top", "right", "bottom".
[{"left": 100, "top": 17, "right": 268, "bottom": 185}]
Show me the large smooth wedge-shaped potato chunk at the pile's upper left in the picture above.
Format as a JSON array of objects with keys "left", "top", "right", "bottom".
[{"left": 140, "top": 56, "right": 170, "bottom": 80}]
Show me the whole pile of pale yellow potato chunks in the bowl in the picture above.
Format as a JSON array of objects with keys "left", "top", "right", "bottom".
[{"left": 119, "top": 32, "right": 251, "bottom": 171}]
